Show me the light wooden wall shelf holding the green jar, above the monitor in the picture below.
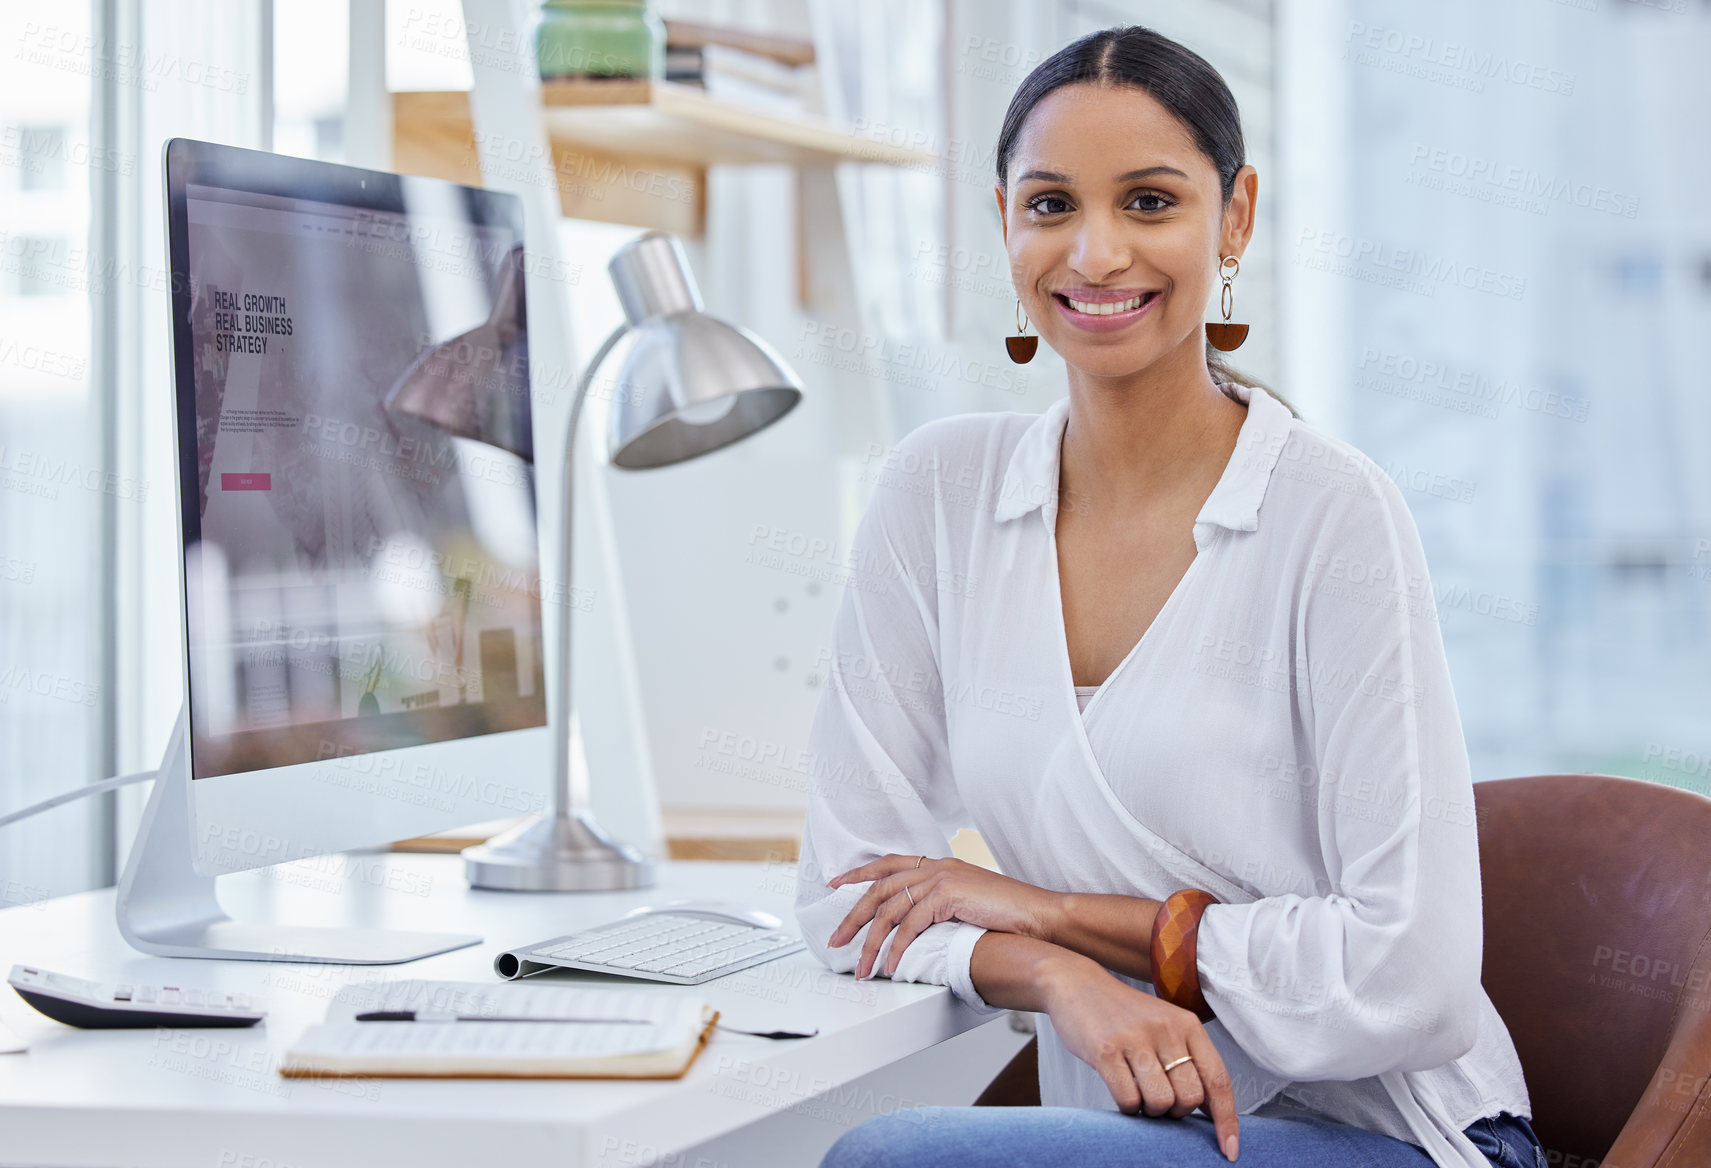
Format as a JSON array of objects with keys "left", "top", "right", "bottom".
[{"left": 392, "top": 80, "right": 936, "bottom": 236}]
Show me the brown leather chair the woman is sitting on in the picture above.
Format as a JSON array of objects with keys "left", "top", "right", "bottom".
[{"left": 975, "top": 775, "right": 1711, "bottom": 1168}]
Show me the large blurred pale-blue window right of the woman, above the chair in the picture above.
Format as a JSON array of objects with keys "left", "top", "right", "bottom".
[{"left": 1334, "top": 0, "right": 1711, "bottom": 793}]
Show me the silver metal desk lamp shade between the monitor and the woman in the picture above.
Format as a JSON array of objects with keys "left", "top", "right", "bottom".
[{"left": 595, "top": 233, "right": 802, "bottom": 470}]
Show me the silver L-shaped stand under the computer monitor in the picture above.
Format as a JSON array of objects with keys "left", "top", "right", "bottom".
[{"left": 115, "top": 710, "right": 481, "bottom": 964}]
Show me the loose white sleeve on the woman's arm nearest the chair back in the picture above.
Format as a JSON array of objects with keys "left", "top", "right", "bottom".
[{"left": 1196, "top": 460, "right": 1482, "bottom": 1079}]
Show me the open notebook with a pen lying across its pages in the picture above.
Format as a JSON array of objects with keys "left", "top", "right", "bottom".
[{"left": 279, "top": 982, "right": 719, "bottom": 1079}]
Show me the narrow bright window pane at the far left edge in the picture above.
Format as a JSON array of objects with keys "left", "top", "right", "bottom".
[{"left": 0, "top": 3, "right": 105, "bottom": 908}]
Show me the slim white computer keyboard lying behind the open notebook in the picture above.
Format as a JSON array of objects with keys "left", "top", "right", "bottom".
[{"left": 493, "top": 911, "right": 802, "bottom": 985}]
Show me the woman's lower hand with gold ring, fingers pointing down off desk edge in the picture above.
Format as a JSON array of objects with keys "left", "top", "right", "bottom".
[{"left": 1044, "top": 958, "right": 1237, "bottom": 1159}]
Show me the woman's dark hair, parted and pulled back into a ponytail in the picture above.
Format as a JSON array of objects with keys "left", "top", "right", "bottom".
[{"left": 998, "top": 24, "right": 1300, "bottom": 417}]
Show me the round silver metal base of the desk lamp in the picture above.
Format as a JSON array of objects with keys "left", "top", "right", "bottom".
[{"left": 464, "top": 812, "right": 654, "bottom": 893}]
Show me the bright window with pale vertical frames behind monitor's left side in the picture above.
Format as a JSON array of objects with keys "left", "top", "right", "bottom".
[{"left": 0, "top": 0, "right": 272, "bottom": 905}]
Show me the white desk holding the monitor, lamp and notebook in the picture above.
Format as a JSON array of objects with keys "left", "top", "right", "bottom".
[{"left": 0, "top": 853, "right": 1025, "bottom": 1168}]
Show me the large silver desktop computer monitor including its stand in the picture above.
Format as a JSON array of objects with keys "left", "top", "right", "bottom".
[{"left": 120, "top": 139, "right": 548, "bottom": 963}]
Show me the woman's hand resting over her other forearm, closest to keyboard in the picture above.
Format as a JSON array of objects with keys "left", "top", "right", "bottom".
[{"left": 826, "top": 855, "right": 1063, "bottom": 978}]
